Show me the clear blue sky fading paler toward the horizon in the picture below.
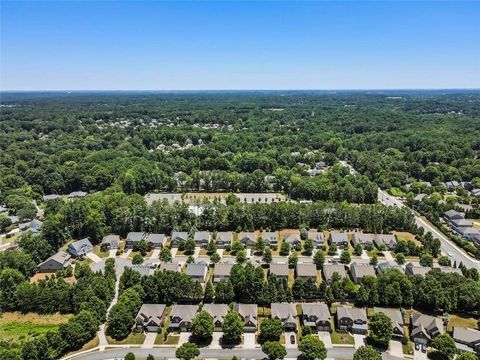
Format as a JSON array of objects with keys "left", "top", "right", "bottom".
[{"left": 0, "top": 1, "right": 480, "bottom": 90}]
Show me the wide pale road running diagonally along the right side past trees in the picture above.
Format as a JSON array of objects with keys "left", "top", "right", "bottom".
[{"left": 378, "top": 189, "right": 480, "bottom": 271}]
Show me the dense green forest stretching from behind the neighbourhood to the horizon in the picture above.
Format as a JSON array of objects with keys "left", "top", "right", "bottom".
[{"left": 0, "top": 92, "right": 480, "bottom": 214}]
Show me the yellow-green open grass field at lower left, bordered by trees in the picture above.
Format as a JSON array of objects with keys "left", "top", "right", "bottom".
[{"left": 0, "top": 312, "right": 71, "bottom": 342}]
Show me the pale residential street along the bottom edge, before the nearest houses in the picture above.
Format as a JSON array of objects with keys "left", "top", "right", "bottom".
[{"left": 62, "top": 347, "right": 403, "bottom": 360}]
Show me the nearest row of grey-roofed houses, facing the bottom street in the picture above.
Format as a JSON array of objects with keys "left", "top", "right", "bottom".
[{"left": 135, "top": 303, "right": 480, "bottom": 352}]
